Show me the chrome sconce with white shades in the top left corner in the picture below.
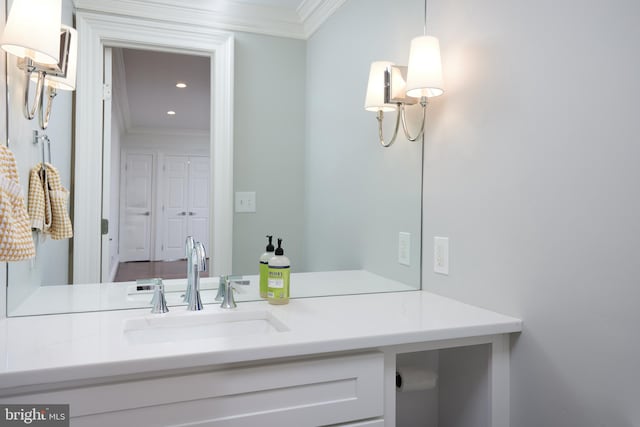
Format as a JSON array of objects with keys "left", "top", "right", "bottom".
[{"left": 0, "top": 0, "right": 78, "bottom": 130}]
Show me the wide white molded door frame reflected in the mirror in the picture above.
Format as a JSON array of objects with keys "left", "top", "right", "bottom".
[{"left": 73, "top": 10, "right": 234, "bottom": 283}]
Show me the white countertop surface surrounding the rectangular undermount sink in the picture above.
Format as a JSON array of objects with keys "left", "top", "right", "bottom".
[{"left": 0, "top": 291, "right": 522, "bottom": 395}]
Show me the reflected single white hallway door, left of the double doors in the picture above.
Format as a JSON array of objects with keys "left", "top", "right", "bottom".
[{"left": 120, "top": 153, "right": 153, "bottom": 262}]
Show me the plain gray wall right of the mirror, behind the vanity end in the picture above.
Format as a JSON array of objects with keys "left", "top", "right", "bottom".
[{"left": 423, "top": 0, "right": 640, "bottom": 427}]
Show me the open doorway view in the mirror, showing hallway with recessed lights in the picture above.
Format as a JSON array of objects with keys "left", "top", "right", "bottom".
[{"left": 108, "top": 47, "right": 211, "bottom": 282}]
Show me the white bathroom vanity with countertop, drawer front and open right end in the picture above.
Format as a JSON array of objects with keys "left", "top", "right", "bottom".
[{"left": 0, "top": 291, "right": 522, "bottom": 427}]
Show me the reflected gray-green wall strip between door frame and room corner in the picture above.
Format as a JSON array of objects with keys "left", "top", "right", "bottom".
[{"left": 229, "top": 33, "right": 306, "bottom": 274}]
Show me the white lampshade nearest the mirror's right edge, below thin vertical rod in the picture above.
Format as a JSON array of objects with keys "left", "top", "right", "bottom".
[{"left": 407, "top": 36, "right": 444, "bottom": 98}]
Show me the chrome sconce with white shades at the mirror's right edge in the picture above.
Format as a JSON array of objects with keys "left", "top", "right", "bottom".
[{"left": 364, "top": 0, "right": 444, "bottom": 148}]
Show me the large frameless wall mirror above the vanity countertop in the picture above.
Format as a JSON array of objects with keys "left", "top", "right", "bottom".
[{"left": 7, "top": 0, "right": 423, "bottom": 316}]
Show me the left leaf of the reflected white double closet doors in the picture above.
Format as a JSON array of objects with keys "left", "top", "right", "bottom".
[{"left": 159, "top": 156, "right": 189, "bottom": 261}]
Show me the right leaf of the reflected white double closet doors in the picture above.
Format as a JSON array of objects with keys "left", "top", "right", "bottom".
[{"left": 188, "top": 157, "right": 210, "bottom": 255}]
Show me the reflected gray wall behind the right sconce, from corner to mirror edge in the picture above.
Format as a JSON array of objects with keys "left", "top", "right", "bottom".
[{"left": 305, "top": 0, "right": 422, "bottom": 287}]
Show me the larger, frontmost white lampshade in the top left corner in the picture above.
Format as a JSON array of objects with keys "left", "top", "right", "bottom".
[{"left": 0, "top": 0, "right": 62, "bottom": 65}]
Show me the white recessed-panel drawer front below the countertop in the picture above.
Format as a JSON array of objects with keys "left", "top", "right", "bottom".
[{"left": 3, "top": 352, "right": 384, "bottom": 427}]
